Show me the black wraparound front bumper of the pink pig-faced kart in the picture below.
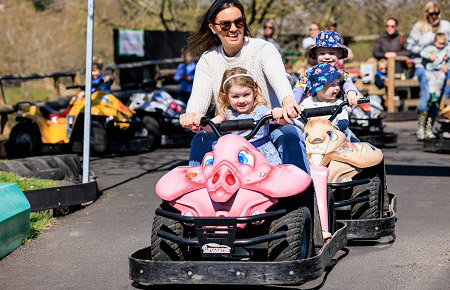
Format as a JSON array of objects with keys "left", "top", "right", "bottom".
[{"left": 128, "top": 223, "right": 347, "bottom": 285}]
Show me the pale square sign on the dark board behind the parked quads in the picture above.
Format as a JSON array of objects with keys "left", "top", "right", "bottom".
[{"left": 119, "top": 29, "right": 145, "bottom": 57}]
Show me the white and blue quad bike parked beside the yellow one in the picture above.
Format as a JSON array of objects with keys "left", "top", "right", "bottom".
[{"left": 127, "top": 83, "right": 193, "bottom": 146}]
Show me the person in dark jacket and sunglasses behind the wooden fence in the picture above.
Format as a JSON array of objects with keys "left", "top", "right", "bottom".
[{"left": 373, "top": 18, "right": 411, "bottom": 60}]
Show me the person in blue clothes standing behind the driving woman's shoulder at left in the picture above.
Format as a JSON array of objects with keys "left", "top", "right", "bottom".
[{"left": 173, "top": 48, "right": 196, "bottom": 104}]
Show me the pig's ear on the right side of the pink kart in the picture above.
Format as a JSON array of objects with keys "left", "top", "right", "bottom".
[{"left": 242, "top": 164, "right": 311, "bottom": 198}]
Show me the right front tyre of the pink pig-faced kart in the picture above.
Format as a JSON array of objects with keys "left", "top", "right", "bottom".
[{"left": 268, "top": 207, "right": 312, "bottom": 261}]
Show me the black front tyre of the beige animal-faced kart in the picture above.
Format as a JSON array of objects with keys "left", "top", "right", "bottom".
[{"left": 351, "top": 166, "right": 385, "bottom": 219}]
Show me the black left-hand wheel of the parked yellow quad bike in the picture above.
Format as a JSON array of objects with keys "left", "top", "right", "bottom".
[{"left": 6, "top": 123, "right": 42, "bottom": 157}]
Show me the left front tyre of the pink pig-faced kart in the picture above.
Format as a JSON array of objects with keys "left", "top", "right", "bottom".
[{"left": 150, "top": 215, "right": 185, "bottom": 261}]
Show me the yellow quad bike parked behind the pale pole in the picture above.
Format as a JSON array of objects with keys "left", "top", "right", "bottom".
[{"left": 6, "top": 90, "right": 154, "bottom": 157}]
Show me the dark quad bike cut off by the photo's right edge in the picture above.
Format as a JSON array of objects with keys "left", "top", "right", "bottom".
[{"left": 423, "top": 106, "right": 450, "bottom": 153}]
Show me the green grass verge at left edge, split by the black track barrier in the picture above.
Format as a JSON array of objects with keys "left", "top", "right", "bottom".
[{"left": 0, "top": 172, "right": 56, "bottom": 243}]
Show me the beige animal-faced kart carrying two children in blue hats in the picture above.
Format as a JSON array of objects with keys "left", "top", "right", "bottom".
[{"left": 302, "top": 98, "right": 396, "bottom": 240}]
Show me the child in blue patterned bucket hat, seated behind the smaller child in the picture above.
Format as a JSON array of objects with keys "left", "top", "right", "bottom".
[{"left": 294, "top": 30, "right": 359, "bottom": 106}]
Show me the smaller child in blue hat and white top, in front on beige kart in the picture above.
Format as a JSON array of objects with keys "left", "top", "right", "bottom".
[{"left": 300, "top": 63, "right": 359, "bottom": 142}]
